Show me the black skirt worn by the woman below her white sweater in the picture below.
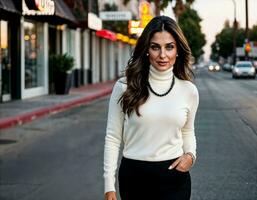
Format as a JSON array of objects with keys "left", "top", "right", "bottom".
[{"left": 118, "top": 157, "right": 191, "bottom": 200}]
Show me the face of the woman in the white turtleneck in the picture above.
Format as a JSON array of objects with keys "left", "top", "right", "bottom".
[{"left": 148, "top": 31, "right": 177, "bottom": 71}]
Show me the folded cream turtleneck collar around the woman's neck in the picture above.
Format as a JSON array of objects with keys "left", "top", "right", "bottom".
[{"left": 149, "top": 65, "right": 173, "bottom": 81}]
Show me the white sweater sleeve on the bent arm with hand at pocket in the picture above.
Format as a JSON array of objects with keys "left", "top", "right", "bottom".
[{"left": 181, "top": 85, "right": 199, "bottom": 158}]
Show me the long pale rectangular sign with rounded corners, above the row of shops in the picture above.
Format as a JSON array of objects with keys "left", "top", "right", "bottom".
[{"left": 99, "top": 11, "right": 132, "bottom": 21}]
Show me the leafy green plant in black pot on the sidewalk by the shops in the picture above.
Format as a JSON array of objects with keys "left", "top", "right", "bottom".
[{"left": 49, "top": 53, "right": 74, "bottom": 94}]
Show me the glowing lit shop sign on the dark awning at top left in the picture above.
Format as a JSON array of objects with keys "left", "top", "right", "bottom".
[{"left": 22, "top": 0, "right": 55, "bottom": 15}]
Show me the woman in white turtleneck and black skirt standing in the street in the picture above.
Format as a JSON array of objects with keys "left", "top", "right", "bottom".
[{"left": 104, "top": 16, "right": 199, "bottom": 200}]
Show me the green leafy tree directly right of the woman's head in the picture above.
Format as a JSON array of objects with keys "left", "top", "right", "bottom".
[{"left": 178, "top": 5, "right": 206, "bottom": 60}]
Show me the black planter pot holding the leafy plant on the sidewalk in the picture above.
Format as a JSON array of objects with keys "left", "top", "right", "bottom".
[{"left": 54, "top": 72, "right": 72, "bottom": 94}]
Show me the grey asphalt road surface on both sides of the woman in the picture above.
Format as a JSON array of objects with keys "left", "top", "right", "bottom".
[{"left": 0, "top": 69, "right": 257, "bottom": 200}]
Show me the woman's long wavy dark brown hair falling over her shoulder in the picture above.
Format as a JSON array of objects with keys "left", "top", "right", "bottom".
[{"left": 119, "top": 16, "right": 194, "bottom": 116}]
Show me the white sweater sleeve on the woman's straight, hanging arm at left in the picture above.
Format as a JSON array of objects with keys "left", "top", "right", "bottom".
[{"left": 103, "top": 81, "right": 124, "bottom": 193}]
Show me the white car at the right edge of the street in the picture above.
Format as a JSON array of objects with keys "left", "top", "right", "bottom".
[{"left": 232, "top": 61, "right": 256, "bottom": 78}]
